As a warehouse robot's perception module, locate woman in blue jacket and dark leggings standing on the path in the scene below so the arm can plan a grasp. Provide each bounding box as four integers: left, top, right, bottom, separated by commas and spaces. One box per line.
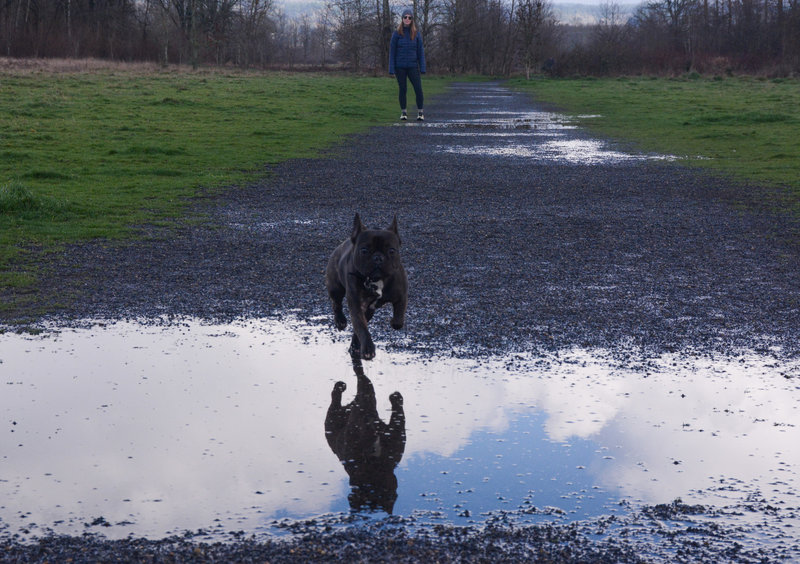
389, 8, 425, 121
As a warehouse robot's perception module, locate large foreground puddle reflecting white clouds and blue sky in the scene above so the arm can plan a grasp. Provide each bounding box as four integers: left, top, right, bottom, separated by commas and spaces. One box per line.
0, 320, 800, 537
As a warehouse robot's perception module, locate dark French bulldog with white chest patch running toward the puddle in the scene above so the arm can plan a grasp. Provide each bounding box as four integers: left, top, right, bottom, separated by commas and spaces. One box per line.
325, 214, 408, 360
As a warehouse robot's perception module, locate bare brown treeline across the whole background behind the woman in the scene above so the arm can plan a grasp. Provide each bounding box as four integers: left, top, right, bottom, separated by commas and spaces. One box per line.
0, 0, 800, 75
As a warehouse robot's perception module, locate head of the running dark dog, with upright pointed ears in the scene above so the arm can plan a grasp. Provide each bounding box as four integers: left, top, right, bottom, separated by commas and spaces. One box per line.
350, 214, 403, 288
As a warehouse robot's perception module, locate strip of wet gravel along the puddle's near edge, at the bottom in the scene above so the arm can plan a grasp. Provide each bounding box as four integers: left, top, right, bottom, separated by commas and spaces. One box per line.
0, 508, 798, 564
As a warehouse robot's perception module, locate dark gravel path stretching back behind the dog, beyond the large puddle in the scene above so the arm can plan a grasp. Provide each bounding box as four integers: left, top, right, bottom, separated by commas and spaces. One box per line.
14, 83, 800, 355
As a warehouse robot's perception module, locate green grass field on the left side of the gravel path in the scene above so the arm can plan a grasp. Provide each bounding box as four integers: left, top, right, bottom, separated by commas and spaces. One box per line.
0, 69, 447, 307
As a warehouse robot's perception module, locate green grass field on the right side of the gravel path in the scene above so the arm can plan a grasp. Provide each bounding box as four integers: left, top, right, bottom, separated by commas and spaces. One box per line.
511, 75, 800, 194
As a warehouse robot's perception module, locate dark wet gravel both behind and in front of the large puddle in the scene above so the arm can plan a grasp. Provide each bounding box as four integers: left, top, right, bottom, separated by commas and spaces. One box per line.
0, 83, 800, 562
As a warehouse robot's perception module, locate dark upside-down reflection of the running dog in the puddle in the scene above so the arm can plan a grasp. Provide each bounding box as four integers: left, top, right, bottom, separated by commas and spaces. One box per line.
325, 359, 406, 513
